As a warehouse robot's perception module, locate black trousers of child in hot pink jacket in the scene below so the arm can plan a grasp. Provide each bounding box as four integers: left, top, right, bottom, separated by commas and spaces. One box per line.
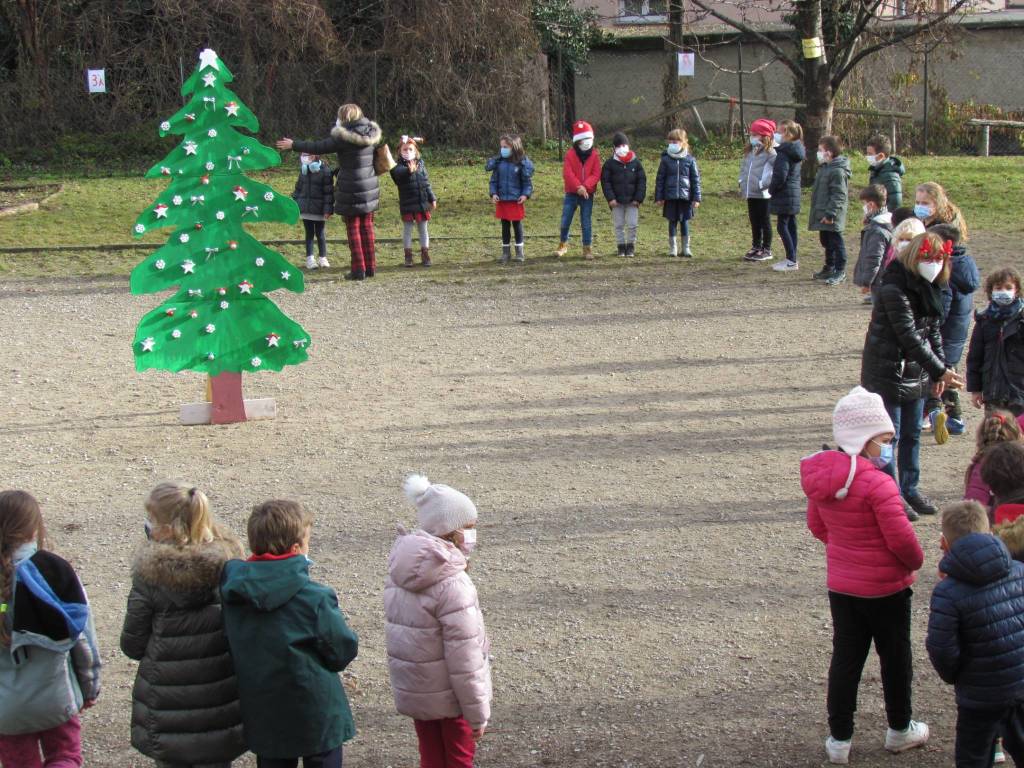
828, 588, 913, 741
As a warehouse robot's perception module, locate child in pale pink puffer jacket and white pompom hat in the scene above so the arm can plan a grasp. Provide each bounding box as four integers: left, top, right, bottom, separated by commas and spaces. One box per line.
384, 475, 490, 768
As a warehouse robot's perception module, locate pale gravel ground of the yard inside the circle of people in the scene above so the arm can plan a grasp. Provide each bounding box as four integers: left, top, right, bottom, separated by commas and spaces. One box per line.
0, 254, 991, 768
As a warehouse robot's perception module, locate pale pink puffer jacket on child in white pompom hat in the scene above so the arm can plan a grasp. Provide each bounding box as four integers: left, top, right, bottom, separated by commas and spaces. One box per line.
384, 530, 490, 728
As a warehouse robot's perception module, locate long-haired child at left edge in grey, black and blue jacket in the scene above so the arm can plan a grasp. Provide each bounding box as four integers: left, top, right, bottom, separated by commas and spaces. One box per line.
0, 490, 101, 768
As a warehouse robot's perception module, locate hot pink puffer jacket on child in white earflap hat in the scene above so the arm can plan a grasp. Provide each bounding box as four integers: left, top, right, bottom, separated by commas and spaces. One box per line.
800, 451, 925, 597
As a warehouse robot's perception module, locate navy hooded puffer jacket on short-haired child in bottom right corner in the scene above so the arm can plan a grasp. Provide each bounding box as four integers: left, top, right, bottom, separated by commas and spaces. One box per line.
926, 534, 1024, 710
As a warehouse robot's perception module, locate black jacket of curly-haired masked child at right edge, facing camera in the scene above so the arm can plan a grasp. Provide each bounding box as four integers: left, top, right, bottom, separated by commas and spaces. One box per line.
967, 301, 1024, 409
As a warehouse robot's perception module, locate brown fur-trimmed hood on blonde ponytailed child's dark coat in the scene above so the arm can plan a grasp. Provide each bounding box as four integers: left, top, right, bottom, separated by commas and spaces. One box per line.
131, 542, 238, 593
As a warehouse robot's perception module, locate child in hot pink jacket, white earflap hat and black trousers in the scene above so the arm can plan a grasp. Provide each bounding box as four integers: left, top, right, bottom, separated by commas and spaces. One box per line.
800, 387, 928, 763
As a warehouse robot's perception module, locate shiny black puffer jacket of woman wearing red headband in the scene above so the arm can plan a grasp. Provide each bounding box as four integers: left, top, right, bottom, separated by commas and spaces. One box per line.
860, 261, 946, 403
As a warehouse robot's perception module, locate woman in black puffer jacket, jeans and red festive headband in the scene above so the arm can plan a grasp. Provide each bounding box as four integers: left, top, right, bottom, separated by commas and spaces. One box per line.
860, 233, 964, 520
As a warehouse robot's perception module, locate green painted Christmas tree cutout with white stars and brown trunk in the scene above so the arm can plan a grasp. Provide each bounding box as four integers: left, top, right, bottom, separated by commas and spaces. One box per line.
131, 48, 309, 424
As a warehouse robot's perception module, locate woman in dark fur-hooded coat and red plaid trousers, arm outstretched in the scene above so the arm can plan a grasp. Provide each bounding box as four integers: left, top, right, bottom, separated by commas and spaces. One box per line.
276, 104, 381, 280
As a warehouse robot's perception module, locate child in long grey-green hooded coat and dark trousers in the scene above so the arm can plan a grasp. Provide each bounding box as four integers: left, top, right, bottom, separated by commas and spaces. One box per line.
808, 136, 850, 286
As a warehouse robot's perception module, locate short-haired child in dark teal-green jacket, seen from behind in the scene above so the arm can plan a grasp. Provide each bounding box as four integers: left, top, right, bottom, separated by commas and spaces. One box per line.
220, 501, 358, 768
